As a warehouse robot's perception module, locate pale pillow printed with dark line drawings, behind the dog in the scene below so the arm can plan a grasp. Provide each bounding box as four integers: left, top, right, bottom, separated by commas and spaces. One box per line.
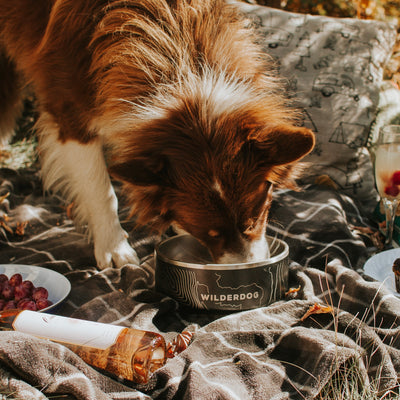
237, 3, 396, 213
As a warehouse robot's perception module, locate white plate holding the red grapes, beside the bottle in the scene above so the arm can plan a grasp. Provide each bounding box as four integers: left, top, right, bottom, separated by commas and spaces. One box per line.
0, 264, 71, 311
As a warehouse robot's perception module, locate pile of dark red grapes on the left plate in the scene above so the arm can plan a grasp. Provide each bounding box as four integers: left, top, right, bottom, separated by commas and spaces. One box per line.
0, 274, 53, 311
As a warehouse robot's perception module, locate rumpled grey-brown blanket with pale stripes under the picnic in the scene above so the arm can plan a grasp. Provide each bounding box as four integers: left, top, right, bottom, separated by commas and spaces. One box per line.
0, 169, 400, 400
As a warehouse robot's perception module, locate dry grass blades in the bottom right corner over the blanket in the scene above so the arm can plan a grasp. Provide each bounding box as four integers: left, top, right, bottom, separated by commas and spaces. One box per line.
287, 273, 400, 400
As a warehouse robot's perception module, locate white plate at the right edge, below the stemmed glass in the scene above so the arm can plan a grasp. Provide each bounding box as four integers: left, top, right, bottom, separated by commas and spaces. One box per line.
364, 248, 400, 297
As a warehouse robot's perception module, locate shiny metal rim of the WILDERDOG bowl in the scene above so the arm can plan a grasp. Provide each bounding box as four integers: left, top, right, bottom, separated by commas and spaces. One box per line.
155, 234, 289, 271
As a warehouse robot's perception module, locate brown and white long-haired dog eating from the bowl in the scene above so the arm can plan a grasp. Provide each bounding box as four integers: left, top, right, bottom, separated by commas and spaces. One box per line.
0, 0, 314, 268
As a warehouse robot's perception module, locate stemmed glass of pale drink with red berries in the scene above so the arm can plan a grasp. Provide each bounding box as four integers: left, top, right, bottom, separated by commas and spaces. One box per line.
375, 125, 400, 248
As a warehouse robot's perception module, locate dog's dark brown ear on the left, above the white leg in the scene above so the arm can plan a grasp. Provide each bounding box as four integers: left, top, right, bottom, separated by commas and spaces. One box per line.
109, 157, 168, 186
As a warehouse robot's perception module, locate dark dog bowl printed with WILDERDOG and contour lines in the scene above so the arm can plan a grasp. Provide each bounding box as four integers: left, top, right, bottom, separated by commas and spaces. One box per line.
155, 235, 289, 311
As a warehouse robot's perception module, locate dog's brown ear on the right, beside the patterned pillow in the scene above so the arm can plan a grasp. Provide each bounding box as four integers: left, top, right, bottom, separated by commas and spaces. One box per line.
249, 125, 315, 165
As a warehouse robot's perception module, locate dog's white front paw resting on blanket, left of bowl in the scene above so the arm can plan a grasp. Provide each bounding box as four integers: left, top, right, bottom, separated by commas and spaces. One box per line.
94, 234, 140, 269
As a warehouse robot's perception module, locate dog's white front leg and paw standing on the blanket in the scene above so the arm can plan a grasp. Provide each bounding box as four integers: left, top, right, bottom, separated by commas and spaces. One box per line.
37, 114, 139, 269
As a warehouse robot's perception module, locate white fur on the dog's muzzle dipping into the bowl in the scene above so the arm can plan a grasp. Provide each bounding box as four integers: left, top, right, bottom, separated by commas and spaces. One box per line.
217, 235, 270, 264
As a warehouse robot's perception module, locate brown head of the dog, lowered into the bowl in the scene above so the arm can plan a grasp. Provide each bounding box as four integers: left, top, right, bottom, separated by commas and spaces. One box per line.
111, 99, 314, 263
